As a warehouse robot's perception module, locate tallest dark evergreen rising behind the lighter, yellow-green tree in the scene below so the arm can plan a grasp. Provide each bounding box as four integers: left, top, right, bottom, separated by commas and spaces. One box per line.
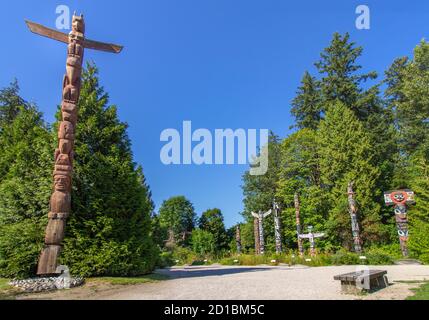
315, 33, 398, 228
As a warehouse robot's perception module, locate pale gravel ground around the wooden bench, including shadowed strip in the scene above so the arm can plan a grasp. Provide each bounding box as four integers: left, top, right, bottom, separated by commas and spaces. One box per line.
18, 265, 429, 300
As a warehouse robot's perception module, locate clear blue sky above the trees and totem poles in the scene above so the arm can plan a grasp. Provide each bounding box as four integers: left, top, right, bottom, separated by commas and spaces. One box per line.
0, 0, 429, 226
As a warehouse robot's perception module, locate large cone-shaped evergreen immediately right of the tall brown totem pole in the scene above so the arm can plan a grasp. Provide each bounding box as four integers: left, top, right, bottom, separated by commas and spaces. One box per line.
62, 64, 157, 276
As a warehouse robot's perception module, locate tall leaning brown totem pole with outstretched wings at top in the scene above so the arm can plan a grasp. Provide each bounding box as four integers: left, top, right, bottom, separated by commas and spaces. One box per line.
26, 15, 122, 276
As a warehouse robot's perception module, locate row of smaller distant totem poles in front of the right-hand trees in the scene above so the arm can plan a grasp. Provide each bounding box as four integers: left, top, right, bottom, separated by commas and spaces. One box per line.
236, 182, 415, 257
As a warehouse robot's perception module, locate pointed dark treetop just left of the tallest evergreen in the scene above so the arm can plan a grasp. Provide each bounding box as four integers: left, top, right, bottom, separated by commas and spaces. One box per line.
291, 71, 322, 129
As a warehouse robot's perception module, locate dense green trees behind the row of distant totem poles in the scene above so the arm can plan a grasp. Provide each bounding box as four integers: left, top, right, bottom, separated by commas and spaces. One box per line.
242, 33, 429, 262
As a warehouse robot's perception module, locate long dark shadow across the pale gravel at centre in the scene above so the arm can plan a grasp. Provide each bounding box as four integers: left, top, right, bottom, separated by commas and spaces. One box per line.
156, 267, 272, 279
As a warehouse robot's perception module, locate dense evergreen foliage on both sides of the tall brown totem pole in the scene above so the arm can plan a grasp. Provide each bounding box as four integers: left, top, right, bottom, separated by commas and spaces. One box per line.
0, 65, 158, 277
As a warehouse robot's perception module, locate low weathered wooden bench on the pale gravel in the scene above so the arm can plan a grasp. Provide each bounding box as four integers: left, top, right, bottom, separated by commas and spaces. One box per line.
334, 270, 389, 293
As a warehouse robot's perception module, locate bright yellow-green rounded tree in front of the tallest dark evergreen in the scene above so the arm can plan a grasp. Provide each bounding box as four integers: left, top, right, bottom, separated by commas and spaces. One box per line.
318, 102, 385, 248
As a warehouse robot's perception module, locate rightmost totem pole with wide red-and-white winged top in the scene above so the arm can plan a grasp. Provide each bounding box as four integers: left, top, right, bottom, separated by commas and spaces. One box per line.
384, 189, 416, 257
